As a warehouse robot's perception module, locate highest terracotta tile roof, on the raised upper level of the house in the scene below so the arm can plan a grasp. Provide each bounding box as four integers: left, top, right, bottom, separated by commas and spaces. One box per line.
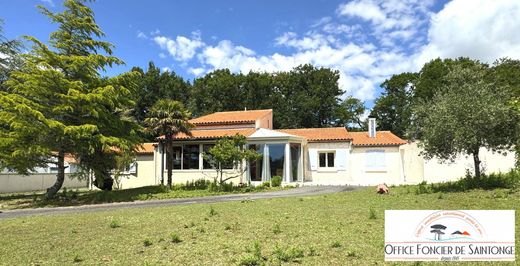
190, 109, 273, 125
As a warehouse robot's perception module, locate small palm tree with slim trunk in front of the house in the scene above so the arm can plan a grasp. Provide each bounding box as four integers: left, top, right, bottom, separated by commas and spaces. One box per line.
144, 99, 194, 188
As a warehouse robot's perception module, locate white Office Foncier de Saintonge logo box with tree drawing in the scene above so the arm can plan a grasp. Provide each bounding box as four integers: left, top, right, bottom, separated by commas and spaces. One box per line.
384, 210, 515, 261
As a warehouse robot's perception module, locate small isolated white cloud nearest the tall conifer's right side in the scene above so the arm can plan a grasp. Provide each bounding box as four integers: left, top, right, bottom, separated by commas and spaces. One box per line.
153, 36, 204, 61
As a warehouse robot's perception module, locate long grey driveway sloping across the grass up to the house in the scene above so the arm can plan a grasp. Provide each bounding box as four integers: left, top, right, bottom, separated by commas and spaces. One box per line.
0, 186, 358, 219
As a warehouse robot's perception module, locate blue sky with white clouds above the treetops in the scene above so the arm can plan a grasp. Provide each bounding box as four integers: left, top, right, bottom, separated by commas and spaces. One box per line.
0, 0, 520, 106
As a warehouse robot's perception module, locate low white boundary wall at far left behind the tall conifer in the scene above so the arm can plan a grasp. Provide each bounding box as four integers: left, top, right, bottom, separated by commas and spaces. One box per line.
0, 174, 87, 193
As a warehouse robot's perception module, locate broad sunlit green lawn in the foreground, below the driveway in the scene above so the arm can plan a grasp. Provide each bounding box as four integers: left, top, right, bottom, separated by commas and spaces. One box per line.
0, 186, 520, 265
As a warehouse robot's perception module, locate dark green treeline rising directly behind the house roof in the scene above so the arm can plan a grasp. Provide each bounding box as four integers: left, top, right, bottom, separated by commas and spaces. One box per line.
131, 62, 365, 140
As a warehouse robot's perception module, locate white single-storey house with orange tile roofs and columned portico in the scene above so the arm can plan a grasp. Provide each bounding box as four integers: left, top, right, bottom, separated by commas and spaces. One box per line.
122, 109, 414, 188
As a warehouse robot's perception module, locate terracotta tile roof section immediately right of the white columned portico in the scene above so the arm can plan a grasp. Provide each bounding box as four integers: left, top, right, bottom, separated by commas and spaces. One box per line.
276, 127, 351, 142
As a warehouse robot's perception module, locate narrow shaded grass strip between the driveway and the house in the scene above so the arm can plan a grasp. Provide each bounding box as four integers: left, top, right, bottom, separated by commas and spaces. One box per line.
0, 185, 285, 210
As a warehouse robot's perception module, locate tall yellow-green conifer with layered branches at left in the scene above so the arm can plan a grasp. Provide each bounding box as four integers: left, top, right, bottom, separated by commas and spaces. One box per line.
0, 0, 139, 198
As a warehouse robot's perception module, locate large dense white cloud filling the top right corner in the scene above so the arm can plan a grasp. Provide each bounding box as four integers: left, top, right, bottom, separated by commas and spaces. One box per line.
418, 0, 520, 62
